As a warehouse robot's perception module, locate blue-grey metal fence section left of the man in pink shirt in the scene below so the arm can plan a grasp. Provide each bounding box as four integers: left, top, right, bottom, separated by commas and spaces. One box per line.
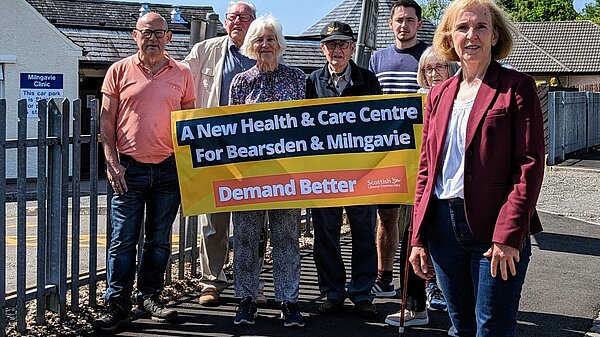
0, 99, 99, 335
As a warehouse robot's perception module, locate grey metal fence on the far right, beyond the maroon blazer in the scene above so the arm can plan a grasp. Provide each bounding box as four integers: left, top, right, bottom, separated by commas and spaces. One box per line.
547, 91, 600, 165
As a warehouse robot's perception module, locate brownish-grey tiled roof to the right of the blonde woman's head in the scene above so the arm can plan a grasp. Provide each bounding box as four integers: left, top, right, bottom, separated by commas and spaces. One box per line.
506, 21, 600, 73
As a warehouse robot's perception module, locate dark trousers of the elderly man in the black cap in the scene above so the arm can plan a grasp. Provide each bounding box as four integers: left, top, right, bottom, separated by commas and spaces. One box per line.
312, 206, 377, 303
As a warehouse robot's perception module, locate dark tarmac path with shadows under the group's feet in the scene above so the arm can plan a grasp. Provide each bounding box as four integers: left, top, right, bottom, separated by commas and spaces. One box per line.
97, 209, 600, 337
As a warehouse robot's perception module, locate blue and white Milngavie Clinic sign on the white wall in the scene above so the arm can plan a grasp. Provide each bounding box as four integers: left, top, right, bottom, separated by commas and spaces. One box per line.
20, 73, 64, 117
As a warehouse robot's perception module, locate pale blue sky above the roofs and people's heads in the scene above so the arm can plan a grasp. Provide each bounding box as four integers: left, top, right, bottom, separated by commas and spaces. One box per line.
112, 0, 593, 36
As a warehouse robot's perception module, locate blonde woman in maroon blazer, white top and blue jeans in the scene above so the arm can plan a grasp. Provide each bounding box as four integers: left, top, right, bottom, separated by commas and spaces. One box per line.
410, 0, 544, 337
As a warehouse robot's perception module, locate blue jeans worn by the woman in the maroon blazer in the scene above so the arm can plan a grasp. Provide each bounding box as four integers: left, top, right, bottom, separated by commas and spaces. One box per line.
426, 200, 531, 337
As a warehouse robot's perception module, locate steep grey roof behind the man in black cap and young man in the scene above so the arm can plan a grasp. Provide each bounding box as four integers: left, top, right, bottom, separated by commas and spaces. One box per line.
301, 0, 435, 49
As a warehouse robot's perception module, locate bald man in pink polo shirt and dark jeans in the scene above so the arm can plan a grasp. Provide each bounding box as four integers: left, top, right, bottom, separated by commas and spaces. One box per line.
92, 12, 196, 332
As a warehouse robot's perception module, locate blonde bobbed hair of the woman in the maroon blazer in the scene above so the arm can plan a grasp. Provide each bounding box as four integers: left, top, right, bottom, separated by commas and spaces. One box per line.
433, 0, 517, 61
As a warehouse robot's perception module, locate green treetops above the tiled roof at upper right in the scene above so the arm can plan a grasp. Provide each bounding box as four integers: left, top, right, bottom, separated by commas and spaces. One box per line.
505, 0, 580, 22
